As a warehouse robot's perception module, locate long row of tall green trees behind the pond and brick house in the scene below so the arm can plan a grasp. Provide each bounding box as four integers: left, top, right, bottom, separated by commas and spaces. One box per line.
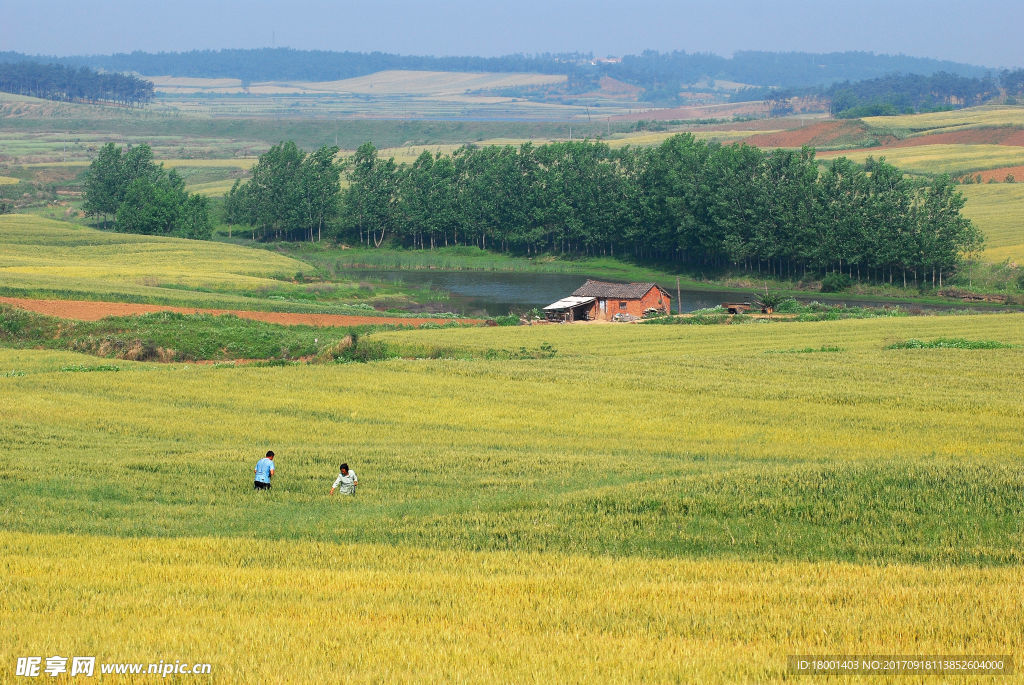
225, 134, 982, 283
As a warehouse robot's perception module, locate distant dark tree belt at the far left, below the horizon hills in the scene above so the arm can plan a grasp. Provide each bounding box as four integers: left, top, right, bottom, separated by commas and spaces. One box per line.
0, 61, 153, 106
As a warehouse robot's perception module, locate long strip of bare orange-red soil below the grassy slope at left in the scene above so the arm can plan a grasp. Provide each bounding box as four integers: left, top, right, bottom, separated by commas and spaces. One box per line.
0, 297, 483, 328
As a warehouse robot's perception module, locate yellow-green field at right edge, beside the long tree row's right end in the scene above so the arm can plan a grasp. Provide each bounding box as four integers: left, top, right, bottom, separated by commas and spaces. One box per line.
959, 183, 1024, 263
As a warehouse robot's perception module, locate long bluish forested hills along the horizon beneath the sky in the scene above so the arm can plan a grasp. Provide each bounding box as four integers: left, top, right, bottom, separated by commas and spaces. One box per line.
0, 48, 989, 94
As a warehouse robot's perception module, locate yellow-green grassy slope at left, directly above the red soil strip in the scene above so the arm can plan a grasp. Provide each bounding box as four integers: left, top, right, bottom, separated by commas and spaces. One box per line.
0, 214, 432, 313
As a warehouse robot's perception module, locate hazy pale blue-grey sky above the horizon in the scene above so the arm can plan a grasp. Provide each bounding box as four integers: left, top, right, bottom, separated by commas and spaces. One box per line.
8, 0, 1024, 67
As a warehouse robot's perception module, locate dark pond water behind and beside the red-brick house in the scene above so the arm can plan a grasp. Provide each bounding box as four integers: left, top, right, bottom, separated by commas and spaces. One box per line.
352, 269, 911, 316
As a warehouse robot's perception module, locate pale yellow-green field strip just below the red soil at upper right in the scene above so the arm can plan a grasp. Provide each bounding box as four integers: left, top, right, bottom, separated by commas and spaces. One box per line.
818, 144, 1024, 176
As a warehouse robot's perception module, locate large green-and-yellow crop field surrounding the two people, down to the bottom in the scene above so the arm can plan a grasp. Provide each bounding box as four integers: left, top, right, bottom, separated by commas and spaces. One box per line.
0, 314, 1024, 682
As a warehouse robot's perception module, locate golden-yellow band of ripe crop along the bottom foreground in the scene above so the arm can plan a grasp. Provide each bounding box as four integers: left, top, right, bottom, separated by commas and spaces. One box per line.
0, 528, 1024, 683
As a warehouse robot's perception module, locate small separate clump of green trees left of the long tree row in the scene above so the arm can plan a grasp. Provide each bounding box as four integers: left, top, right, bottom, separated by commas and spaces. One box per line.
83, 142, 213, 240
